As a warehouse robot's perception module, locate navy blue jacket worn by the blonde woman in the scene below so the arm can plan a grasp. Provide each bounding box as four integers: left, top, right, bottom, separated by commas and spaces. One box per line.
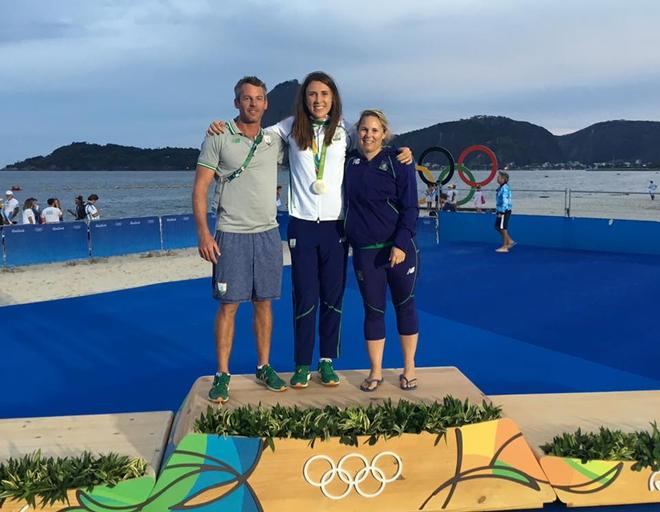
344, 147, 419, 251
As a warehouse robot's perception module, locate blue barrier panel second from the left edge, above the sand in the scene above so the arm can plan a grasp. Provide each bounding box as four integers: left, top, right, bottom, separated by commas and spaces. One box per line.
89, 217, 161, 257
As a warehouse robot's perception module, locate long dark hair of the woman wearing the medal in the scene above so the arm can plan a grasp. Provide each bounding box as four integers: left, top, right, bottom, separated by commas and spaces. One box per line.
291, 71, 341, 151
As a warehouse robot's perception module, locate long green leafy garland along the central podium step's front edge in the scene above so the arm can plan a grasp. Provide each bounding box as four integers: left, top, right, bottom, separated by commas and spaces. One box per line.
194, 396, 501, 449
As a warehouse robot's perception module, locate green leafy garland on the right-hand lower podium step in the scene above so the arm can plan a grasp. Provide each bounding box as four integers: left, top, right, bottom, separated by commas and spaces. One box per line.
541, 422, 660, 471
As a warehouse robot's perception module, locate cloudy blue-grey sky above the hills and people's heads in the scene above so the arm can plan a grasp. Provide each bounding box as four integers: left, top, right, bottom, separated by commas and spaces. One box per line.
0, 0, 660, 168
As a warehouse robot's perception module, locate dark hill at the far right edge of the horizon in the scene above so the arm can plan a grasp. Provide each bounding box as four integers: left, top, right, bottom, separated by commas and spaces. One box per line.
557, 121, 660, 162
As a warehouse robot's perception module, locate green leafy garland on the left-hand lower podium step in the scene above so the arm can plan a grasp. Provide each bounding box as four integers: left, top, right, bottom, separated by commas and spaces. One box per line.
0, 451, 147, 508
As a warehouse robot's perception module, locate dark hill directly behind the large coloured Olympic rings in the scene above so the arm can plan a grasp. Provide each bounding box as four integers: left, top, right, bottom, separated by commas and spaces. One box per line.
393, 116, 564, 165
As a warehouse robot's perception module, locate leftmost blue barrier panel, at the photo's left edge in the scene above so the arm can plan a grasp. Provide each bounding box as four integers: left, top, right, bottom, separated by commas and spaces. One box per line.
2, 222, 89, 266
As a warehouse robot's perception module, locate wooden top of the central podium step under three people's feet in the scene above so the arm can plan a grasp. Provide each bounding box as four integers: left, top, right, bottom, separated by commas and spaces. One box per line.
170, 367, 488, 443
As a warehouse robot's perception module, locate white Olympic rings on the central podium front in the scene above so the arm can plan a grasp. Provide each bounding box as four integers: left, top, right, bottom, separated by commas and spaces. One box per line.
303, 452, 403, 500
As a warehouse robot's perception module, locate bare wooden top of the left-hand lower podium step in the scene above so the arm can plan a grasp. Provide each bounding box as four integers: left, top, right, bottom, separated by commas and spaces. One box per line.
0, 411, 173, 471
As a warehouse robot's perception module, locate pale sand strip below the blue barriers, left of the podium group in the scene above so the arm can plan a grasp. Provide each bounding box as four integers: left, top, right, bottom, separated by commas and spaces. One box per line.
0, 244, 291, 306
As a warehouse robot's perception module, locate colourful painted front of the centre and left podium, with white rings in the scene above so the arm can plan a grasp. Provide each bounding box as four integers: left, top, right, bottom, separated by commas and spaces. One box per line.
0, 419, 556, 512
